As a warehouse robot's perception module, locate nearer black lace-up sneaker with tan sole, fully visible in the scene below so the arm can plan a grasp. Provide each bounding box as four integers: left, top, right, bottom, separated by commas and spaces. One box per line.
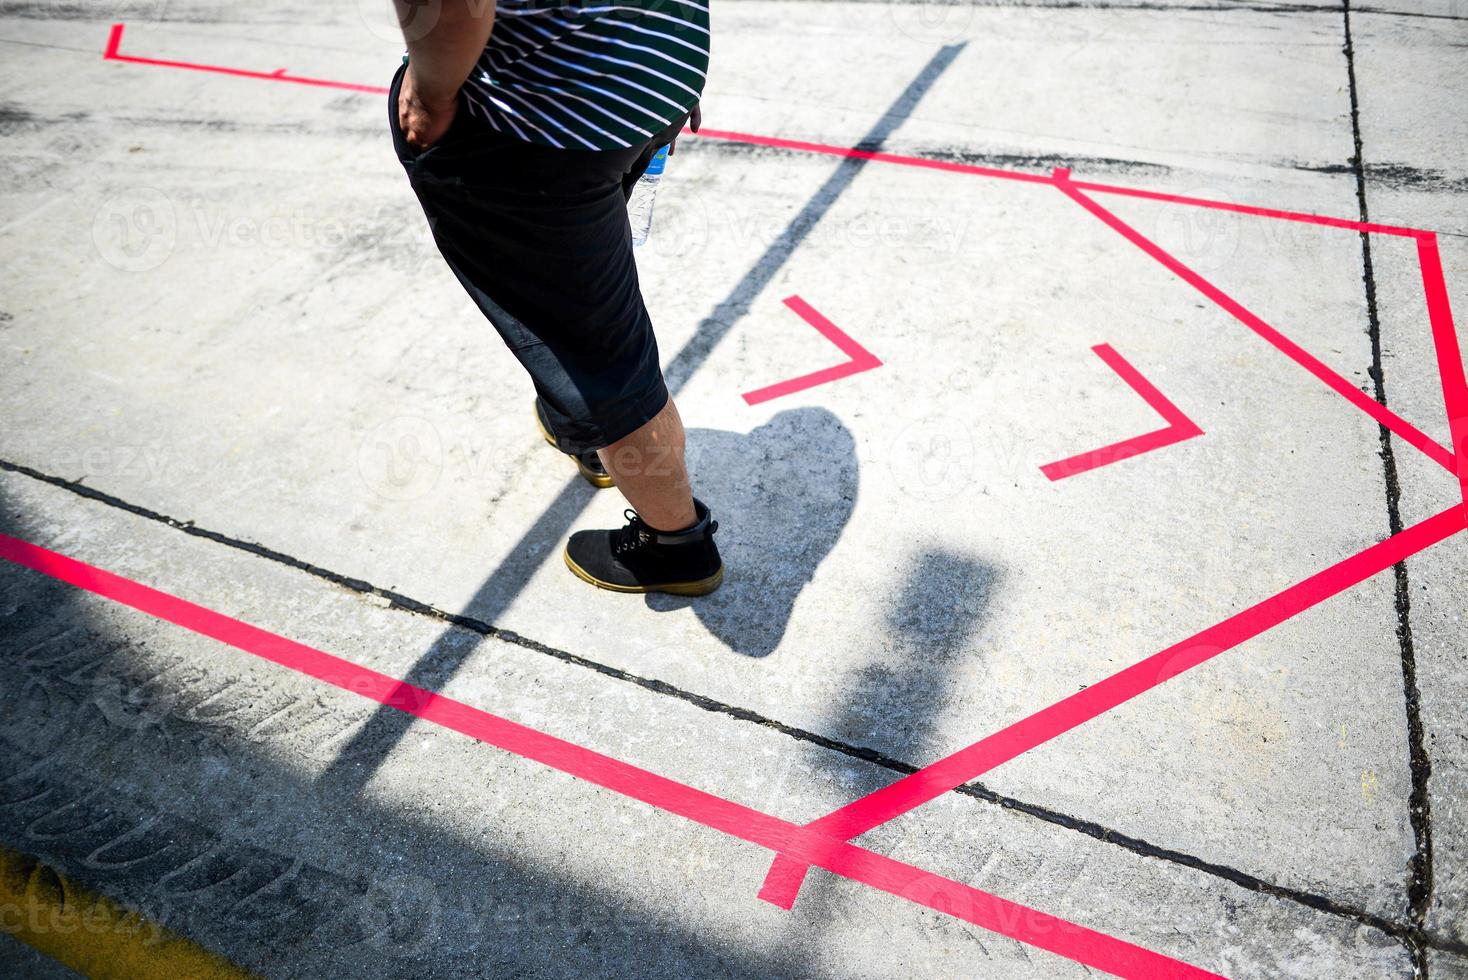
565, 500, 724, 596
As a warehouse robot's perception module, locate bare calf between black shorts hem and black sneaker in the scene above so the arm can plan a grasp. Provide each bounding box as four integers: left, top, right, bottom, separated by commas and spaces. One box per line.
597, 398, 697, 531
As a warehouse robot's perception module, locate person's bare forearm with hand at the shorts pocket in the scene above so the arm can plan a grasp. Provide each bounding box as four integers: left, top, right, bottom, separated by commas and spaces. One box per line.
393, 0, 495, 150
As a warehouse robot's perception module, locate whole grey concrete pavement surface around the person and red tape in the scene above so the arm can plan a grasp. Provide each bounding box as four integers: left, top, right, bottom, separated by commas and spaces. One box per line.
0, 0, 1468, 977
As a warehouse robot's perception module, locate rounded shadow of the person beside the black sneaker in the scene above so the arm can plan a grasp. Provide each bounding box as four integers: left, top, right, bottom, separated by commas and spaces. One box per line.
647, 408, 857, 657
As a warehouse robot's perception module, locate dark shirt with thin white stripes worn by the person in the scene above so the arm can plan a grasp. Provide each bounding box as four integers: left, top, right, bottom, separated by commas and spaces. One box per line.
464, 0, 709, 150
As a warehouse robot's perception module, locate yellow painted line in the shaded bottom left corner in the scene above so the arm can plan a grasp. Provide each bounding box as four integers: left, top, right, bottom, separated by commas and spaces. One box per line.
0, 846, 251, 980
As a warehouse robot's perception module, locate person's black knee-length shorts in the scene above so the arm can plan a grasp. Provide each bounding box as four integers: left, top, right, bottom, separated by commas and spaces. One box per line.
388, 66, 683, 453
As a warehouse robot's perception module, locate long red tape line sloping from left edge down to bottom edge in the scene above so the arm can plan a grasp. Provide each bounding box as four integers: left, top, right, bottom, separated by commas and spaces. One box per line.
0, 534, 1218, 980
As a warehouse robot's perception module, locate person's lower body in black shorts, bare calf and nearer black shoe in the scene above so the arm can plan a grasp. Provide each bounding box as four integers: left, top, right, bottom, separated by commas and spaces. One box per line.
389, 72, 724, 596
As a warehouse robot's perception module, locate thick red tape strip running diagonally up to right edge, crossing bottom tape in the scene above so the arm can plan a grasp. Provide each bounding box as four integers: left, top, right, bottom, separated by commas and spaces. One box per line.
759, 506, 1468, 908
